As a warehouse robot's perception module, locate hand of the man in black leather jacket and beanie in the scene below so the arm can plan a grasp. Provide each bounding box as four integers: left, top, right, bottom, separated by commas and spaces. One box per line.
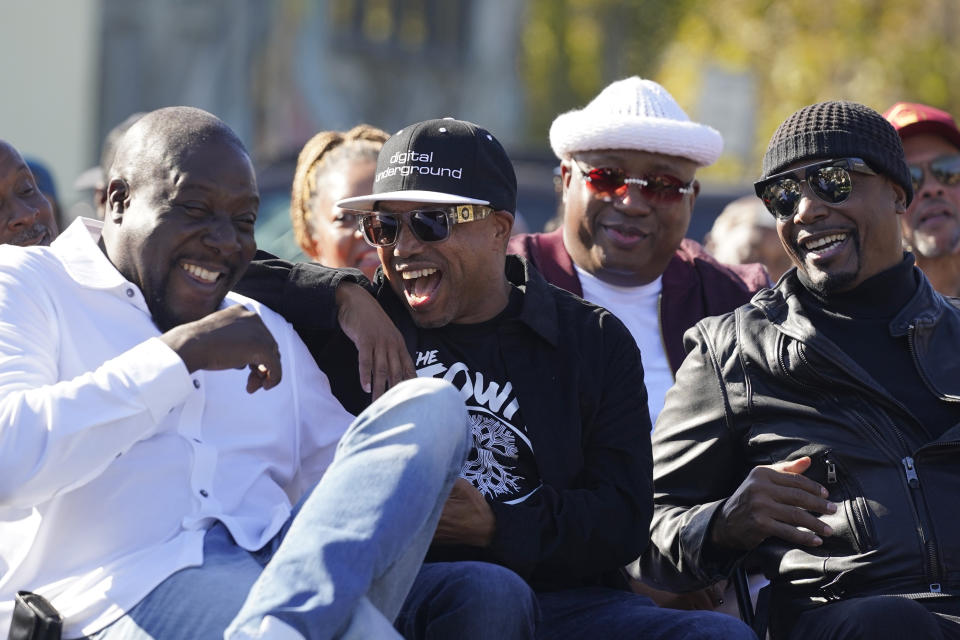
710, 456, 837, 550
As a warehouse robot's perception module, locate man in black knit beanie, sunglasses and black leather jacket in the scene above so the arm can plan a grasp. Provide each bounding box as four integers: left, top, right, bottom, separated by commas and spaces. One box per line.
643, 101, 960, 640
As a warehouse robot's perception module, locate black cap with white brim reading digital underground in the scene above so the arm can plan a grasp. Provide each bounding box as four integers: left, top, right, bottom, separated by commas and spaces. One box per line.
337, 118, 517, 213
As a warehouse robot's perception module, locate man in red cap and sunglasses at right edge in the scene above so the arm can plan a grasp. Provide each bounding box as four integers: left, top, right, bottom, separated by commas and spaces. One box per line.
883, 102, 960, 296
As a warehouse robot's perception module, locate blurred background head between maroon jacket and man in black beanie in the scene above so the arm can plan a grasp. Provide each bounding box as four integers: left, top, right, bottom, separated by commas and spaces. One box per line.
704, 195, 791, 282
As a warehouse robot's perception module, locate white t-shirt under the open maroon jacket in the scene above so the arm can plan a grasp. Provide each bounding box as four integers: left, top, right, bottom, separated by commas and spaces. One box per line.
574, 265, 673, 424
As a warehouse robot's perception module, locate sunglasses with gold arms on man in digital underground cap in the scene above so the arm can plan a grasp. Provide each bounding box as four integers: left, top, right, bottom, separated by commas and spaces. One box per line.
360, 204, 493, 247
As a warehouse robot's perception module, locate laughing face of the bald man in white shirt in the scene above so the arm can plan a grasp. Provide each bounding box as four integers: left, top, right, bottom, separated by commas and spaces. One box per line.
104, 127, 259, 331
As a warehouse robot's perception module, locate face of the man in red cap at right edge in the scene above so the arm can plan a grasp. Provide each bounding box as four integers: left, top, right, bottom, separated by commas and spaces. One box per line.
901, 134, 960, 259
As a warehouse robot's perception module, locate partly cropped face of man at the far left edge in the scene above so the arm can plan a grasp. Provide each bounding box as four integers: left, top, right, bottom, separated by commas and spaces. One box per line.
0, 140, 57, 247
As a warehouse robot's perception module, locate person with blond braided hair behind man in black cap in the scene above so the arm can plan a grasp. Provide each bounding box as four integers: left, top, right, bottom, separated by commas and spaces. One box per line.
290, 124, 389, 278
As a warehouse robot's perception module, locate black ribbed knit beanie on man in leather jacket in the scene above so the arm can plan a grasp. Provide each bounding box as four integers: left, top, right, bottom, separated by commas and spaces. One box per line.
761, 100, 913, 206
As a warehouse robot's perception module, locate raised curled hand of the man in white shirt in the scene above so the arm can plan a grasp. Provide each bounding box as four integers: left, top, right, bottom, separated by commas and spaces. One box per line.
160, 305, 282, 393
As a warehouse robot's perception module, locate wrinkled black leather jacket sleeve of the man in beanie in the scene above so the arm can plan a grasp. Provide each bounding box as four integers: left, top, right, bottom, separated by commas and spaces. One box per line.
642, 312, 745, 591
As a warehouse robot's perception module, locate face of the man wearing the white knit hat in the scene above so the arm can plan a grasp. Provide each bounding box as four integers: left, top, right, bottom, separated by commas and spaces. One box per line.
561, 150, 699, 286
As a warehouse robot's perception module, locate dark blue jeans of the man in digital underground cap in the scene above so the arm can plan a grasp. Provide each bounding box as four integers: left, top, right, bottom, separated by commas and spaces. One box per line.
396, 562, 756, 640
